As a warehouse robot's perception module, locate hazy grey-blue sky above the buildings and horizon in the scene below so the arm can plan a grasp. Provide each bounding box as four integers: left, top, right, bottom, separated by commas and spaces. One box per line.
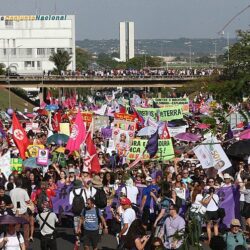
0, 0, 250, 40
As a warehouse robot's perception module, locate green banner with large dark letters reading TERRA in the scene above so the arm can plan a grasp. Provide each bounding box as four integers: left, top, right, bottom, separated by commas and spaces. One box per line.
136, 106, 183, 122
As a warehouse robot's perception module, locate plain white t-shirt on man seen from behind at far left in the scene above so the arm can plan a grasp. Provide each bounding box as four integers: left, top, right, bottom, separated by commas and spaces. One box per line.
10, 187, 30, 214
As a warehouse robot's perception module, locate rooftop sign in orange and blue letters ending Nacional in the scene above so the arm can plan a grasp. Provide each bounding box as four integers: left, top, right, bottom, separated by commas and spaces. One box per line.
0, 15, 67, 21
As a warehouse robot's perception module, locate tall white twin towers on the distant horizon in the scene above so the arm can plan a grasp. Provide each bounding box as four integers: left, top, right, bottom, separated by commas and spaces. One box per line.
120, 22, 135, 62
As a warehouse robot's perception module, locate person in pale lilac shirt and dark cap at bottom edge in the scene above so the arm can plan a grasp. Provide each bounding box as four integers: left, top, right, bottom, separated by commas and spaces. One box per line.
163, 204, 186, 250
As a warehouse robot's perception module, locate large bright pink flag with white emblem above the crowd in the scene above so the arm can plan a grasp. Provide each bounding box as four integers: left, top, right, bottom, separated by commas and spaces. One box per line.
66, 111, 86, 152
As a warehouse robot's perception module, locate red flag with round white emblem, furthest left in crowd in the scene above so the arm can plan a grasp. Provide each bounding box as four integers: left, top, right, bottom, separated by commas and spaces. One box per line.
12, 113, 29, 159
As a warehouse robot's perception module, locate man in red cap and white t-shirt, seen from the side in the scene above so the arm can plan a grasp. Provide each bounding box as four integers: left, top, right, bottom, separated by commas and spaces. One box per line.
119, 197, 136, 242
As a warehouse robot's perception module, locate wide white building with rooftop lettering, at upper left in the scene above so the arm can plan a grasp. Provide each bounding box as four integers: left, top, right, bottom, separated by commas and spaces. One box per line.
0, 15, 75, 74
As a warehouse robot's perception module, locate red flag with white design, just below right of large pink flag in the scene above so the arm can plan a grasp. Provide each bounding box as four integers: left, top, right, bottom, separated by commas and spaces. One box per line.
84, 133, 101, 173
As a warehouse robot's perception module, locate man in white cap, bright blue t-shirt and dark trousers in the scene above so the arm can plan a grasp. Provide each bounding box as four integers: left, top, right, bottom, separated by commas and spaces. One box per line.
140, 176, 160, 229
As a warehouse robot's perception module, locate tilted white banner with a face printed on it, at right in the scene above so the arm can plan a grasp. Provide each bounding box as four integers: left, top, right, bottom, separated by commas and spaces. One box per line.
193, 137, 232, 173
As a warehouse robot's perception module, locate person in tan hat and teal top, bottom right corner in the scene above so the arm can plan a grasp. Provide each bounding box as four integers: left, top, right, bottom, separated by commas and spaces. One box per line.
223, 219, 247, 250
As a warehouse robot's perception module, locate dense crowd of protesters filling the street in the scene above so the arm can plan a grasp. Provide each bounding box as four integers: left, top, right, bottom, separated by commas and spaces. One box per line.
0, 90, 250, 250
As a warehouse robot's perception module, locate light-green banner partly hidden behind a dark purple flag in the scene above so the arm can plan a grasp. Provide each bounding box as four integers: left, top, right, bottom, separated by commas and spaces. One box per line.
127, 139, 174, 161
